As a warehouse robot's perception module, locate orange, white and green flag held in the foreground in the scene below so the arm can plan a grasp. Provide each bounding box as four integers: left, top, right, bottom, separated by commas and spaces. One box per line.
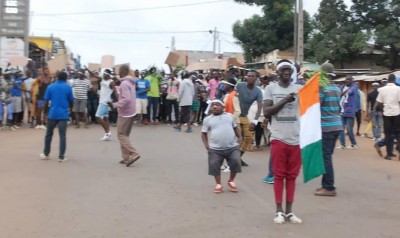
298, 73, 325, 183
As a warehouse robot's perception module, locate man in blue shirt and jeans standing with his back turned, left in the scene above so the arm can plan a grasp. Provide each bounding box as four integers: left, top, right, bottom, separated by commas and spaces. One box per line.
40, 72, 74, 162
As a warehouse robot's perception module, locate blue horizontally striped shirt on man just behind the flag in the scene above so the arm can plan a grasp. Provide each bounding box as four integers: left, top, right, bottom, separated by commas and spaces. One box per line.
319, 85, 343, 132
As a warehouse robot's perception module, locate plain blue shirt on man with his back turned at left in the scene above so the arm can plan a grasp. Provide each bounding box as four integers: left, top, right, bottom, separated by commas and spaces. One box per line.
44, 81, 74, 120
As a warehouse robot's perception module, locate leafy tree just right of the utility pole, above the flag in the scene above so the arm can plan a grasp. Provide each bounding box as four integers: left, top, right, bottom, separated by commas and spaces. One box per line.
306, 0, 367, 68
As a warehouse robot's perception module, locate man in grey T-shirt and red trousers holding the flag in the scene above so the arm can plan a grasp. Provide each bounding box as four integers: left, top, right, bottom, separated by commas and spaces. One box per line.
264, 60, 302, 224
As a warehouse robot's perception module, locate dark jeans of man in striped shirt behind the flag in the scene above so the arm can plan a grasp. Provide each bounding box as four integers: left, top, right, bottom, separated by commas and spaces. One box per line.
322, 131, 342, 191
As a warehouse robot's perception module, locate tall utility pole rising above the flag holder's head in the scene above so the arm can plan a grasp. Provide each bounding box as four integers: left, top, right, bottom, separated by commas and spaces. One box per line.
294, 0, 304, 66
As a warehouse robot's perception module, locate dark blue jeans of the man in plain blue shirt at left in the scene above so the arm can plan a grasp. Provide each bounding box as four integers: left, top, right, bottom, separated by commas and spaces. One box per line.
43, 119, 68, 159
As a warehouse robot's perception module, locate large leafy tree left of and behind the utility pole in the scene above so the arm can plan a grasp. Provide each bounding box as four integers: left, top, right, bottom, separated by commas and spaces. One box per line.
233, 0, 311, 61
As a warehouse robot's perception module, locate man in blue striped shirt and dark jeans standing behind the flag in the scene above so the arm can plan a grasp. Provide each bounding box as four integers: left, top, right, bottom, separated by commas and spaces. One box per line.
314, 63, 343, 196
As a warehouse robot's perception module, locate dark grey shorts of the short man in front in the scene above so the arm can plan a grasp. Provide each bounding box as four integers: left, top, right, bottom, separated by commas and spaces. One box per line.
208, 146, 242, 176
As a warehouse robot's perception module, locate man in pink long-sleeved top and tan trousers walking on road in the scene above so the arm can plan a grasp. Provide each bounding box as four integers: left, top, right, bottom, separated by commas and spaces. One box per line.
108, 65, 140, 167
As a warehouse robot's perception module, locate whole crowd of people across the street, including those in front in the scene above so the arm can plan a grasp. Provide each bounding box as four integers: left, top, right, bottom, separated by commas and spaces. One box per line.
0, 60, 400, 224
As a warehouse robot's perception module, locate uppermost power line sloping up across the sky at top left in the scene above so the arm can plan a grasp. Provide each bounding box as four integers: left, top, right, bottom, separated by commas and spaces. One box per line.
34, 0, 227, 16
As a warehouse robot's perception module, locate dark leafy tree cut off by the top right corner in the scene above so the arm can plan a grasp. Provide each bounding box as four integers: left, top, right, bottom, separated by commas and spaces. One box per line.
351, 0, 400, 69
